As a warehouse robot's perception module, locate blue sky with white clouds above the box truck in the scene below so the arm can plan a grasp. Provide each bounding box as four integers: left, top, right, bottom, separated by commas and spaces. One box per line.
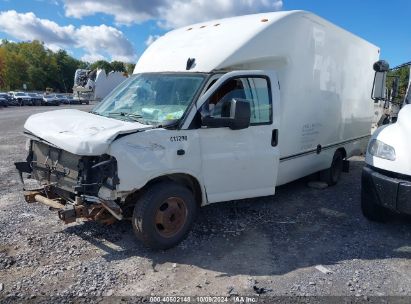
0, 0, 411, 66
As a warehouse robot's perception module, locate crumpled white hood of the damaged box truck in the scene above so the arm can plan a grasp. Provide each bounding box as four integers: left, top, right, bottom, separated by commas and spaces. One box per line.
24, 109, 152, 156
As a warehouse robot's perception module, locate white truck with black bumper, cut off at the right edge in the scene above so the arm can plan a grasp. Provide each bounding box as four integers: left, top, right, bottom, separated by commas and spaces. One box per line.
361, 61, 411, 222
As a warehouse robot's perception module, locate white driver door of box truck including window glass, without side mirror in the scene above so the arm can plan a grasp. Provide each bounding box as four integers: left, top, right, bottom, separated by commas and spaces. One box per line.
193, 71, 279, 203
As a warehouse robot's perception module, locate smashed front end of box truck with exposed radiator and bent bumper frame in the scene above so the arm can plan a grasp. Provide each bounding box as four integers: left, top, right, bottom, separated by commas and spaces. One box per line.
15, 140, 123, 224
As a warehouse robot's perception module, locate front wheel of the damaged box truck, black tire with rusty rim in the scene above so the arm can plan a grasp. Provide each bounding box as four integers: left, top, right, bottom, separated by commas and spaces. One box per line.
132, 182, 197, 250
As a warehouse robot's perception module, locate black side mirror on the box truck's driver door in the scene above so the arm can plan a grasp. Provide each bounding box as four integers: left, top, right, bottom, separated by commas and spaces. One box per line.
202, 99, 251, 130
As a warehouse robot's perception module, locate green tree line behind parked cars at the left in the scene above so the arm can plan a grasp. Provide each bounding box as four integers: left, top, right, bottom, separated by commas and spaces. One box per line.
0, 40, 135, 93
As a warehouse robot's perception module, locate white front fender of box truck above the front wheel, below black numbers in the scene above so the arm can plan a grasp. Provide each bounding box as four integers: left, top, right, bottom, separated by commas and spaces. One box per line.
108, 128, 203, 196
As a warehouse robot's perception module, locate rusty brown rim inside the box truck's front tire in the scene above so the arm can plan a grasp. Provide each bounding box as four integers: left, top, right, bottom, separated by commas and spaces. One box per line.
154, 197, 187, 238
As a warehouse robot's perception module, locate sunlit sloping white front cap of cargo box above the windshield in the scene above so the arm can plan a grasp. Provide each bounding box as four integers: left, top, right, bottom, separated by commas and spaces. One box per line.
134, 12, 296, 73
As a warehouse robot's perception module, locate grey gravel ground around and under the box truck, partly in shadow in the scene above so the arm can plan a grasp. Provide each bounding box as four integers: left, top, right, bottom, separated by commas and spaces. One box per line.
0, 106, 411, 302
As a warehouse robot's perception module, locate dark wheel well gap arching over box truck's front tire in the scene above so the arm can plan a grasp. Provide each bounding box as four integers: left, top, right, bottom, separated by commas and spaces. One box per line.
126, 173, 203, 207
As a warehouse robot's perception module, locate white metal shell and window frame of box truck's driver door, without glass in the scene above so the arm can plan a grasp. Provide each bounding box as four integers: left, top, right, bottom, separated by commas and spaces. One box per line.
198, 71, 280, 203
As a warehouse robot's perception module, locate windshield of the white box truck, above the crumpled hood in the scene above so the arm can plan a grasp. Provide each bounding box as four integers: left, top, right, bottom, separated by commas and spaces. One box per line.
92, 73, 206, 125
